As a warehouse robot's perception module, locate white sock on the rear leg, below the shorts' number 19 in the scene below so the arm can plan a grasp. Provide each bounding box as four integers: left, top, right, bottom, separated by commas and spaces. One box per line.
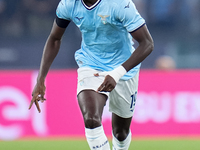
112, 132, 131, 150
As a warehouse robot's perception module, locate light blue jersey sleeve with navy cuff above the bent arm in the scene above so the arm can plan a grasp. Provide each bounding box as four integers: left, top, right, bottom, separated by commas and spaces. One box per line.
117, 0, 145, 32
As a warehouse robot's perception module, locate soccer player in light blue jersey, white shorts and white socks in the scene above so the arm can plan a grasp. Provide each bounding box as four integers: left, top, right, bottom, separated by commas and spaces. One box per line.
29, 0, 154, 150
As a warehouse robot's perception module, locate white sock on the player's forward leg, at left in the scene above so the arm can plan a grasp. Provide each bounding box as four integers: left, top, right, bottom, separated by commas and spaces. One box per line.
85, 126, 110, 150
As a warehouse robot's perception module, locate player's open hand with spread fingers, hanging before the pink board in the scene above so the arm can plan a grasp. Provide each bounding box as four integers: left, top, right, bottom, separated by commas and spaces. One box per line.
29, 83, 46, 113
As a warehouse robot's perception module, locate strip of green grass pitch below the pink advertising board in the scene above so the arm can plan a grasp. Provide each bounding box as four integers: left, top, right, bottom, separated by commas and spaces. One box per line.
0, 138, 200, 150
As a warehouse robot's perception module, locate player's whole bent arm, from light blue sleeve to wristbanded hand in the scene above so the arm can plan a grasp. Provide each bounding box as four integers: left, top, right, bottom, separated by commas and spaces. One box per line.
96, 0, 154, 92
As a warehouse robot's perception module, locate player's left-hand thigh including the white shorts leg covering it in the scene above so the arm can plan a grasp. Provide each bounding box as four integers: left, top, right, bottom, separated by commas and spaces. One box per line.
77, 67, 109, 116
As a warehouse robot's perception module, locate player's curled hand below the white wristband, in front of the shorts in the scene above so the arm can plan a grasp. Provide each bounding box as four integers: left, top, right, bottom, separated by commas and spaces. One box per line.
94, 72, 117, 92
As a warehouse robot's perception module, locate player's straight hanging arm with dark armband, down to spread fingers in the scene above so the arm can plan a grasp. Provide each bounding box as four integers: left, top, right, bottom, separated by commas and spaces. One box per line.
29, 17, 70, 112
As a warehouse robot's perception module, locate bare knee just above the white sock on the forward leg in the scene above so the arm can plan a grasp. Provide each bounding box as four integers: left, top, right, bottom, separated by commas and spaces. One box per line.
84, 116, 101, 129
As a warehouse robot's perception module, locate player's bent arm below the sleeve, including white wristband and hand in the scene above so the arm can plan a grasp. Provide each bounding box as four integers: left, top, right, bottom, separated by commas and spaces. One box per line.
95, 24, 154, 92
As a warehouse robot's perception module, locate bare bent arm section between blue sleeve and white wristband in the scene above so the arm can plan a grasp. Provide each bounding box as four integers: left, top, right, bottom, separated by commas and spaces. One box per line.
122, 24, 154, 72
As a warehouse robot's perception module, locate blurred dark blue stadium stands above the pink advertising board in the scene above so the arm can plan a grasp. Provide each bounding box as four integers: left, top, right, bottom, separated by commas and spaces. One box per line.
0, 0, 200, 69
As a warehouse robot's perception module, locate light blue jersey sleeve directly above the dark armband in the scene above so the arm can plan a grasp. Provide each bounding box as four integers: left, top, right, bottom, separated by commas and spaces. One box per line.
56, 0, 71, 20
